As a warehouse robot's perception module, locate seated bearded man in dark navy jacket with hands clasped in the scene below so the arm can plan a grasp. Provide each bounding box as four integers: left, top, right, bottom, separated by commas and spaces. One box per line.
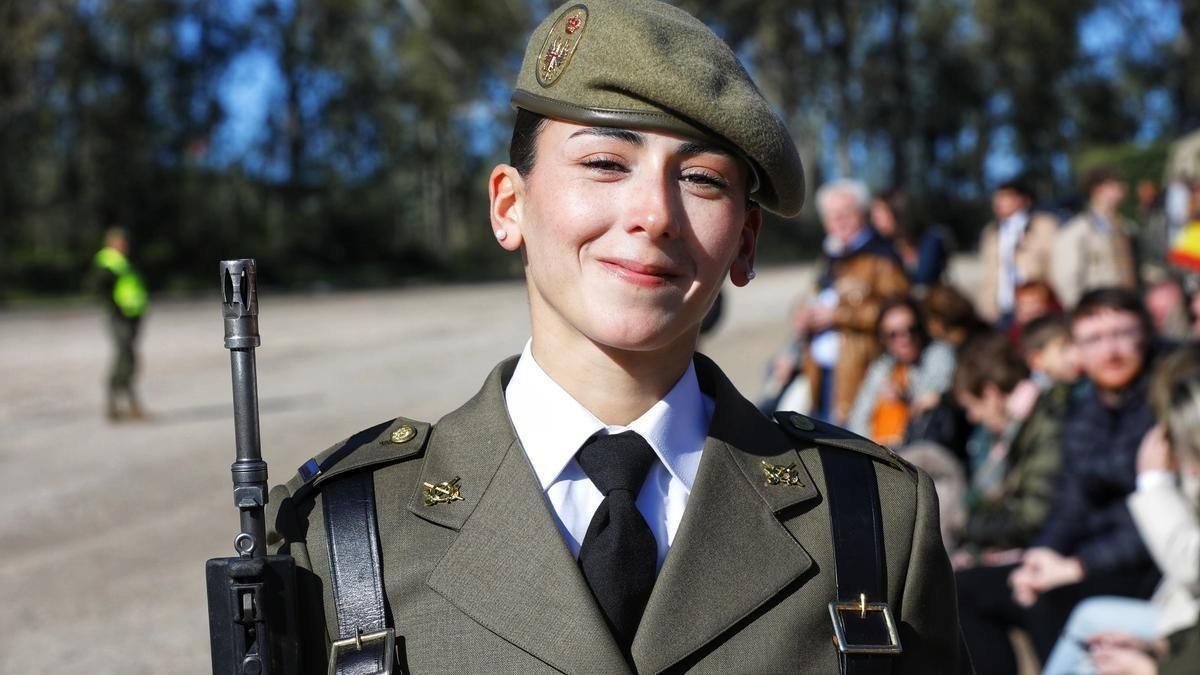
956, 288, 1158, 675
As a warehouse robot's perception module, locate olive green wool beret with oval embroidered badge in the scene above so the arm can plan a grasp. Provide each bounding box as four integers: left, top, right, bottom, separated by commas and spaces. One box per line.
512, 0, 804, 216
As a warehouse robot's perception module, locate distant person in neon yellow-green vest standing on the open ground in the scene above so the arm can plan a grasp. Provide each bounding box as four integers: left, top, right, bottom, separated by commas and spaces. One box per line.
94, 227, 148, 422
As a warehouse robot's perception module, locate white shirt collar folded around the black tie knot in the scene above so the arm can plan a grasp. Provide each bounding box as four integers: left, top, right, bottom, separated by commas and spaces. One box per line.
504, 342, 714, 492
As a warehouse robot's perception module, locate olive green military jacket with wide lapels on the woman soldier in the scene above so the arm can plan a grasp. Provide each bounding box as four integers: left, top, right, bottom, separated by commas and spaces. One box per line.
268, 356, 971, 675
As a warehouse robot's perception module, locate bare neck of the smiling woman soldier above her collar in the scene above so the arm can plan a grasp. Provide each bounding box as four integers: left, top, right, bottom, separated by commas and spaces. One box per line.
530, 322, 696, 426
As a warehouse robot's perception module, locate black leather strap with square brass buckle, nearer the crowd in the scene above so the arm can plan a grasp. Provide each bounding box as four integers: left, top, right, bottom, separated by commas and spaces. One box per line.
821, 446, 898, 675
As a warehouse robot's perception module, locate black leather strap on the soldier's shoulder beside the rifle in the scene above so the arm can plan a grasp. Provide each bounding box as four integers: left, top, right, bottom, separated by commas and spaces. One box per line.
322, 471, 395, 675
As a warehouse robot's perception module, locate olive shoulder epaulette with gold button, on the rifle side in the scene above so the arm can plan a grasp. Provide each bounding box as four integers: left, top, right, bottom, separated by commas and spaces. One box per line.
288, 417, 430, 497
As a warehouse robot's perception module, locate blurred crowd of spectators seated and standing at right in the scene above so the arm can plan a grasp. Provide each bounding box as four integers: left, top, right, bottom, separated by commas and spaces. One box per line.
761, 168, 1200, 674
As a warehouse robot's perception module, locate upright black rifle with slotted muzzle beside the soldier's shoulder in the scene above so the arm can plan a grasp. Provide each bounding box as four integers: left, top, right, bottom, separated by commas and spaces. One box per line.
205, 258, 300, 675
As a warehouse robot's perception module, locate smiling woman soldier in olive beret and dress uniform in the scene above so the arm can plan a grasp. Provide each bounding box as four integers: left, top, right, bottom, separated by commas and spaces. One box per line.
270, 0, 970, 674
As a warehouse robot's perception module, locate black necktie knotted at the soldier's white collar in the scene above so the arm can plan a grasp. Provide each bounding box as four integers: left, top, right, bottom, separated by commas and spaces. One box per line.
576, 431, 658, 655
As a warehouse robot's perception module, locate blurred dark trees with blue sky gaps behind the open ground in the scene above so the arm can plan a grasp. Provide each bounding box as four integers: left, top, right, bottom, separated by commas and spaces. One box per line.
0, 0, 1200, 300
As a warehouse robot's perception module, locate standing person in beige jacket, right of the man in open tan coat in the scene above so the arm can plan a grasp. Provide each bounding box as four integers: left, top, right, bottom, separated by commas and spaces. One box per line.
1050, 167, 1138, 307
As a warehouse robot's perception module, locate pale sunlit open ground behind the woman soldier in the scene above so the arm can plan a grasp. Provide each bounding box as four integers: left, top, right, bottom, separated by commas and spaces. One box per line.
0, 255, 974, 675
